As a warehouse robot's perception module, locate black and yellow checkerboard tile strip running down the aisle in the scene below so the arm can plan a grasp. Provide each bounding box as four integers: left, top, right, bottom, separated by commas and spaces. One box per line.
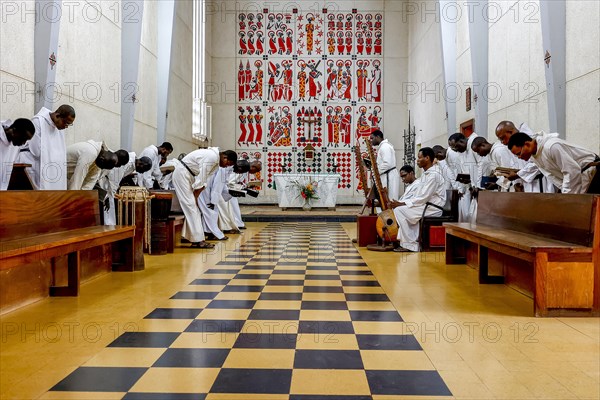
46, 223, 452, 400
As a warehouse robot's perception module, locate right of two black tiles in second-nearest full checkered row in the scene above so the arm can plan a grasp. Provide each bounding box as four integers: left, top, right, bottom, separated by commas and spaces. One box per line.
294, 350, 363, 369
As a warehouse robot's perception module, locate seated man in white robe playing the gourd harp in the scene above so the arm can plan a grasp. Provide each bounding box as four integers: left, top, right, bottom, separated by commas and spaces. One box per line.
390, 147, 446, 252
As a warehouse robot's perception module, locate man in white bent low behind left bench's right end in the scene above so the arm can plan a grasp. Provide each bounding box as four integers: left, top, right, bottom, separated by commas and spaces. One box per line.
67, 140, 119, 190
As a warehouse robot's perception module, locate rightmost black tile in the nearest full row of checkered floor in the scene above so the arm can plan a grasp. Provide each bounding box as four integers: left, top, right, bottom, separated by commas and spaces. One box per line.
367, 371, 452, 396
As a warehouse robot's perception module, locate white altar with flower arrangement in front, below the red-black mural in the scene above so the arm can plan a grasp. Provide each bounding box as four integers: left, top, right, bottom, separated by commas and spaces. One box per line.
273, 174, 342, 209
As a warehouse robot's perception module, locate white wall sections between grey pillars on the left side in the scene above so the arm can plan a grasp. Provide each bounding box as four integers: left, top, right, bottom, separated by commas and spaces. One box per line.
0, 0, 195, 152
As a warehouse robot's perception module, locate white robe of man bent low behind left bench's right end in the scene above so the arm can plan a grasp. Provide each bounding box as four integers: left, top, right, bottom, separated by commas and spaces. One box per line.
67, 140, 106, 190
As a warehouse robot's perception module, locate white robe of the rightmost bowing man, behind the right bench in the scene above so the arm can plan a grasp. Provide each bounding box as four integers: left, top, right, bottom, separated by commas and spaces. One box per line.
530, 132, 596, 194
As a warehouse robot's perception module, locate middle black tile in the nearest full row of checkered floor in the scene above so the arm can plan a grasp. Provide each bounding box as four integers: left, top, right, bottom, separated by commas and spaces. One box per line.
210, 368, 292, 394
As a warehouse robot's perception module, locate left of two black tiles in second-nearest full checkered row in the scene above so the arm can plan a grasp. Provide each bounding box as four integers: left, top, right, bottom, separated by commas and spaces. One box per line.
152, 348, 229, 368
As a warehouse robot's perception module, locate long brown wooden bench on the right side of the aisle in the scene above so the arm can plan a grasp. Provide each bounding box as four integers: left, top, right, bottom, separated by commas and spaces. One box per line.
444, 192, 600, 316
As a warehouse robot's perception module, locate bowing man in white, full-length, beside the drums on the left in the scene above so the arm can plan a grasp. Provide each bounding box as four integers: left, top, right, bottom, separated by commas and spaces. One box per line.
172, 147, 237, 249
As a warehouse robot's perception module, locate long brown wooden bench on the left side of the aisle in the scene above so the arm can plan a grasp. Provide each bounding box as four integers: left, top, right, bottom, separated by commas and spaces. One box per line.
0, 191, 134, 309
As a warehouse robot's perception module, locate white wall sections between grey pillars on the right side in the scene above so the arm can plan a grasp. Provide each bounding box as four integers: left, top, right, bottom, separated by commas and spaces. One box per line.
408, 0, 600, 152
